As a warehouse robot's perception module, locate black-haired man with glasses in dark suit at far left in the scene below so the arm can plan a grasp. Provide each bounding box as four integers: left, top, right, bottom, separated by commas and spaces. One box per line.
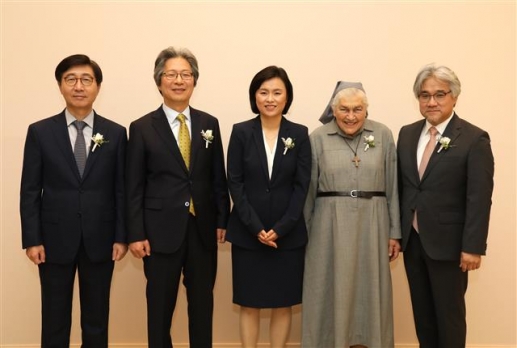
20, 54, 127, 348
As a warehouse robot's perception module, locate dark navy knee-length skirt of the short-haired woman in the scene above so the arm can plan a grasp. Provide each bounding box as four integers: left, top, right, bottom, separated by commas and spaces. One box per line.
232, 244, 305, 308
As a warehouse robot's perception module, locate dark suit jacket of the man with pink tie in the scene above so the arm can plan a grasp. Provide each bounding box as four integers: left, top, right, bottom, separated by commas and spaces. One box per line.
397, 114, 494, 261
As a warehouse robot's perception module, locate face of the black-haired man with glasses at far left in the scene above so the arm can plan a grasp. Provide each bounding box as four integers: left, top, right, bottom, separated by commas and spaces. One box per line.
59, 65, 100, 116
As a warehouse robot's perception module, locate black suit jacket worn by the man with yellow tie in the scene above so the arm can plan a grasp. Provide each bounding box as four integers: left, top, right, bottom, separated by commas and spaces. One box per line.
126, 106, 230, 253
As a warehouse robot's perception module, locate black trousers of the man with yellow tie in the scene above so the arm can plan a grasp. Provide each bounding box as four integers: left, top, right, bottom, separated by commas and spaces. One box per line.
144, 216, 217, 348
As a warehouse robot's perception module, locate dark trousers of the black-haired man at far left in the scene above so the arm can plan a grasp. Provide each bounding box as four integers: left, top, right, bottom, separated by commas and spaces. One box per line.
39, 247, 114, 348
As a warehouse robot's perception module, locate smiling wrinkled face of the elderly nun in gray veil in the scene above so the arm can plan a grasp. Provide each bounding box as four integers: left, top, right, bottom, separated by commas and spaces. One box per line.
333, 95, 367, 135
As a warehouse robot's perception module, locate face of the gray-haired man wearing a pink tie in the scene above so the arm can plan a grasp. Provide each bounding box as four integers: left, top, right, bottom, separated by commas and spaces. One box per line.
418, 77, 458, 126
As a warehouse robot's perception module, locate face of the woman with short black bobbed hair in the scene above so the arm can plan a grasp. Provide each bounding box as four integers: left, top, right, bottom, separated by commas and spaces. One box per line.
255, 77, 287, 117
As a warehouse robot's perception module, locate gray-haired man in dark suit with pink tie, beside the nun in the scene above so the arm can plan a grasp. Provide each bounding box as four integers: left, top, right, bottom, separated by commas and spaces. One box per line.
397, 65, 494, 348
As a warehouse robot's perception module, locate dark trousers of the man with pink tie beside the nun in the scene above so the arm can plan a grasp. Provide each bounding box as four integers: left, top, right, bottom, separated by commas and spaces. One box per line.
403, 229, 468, 348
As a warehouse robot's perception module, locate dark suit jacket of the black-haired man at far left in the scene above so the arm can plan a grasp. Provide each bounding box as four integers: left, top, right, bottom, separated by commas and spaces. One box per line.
20, 111, 127, 263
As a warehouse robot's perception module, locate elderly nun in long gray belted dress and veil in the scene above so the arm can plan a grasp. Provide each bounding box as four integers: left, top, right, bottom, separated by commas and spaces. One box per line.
302, 82, 401, 348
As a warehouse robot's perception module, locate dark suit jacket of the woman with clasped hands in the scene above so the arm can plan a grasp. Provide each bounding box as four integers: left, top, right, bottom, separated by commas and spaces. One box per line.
226, 116, 311, 249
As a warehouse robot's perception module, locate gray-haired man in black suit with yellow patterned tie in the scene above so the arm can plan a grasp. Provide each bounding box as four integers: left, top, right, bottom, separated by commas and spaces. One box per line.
126, 47, 230, 348
